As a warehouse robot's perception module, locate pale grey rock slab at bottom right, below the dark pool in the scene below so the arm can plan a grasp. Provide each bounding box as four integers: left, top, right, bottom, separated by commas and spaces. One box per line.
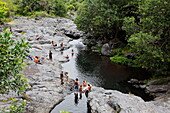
88, 87, 170, 113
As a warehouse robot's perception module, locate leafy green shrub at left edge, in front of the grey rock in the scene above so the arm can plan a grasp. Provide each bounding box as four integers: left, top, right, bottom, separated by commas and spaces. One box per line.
0, 30, 30, 94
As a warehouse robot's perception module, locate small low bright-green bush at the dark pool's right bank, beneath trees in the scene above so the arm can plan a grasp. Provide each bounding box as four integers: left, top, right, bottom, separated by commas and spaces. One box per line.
110, 55, 132, 65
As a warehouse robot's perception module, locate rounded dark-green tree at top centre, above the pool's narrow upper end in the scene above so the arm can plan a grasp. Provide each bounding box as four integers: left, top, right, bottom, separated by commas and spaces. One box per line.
75, 0, 131, 39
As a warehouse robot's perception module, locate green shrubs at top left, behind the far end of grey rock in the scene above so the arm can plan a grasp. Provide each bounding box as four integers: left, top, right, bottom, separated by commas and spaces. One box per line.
14, 0, 67, 16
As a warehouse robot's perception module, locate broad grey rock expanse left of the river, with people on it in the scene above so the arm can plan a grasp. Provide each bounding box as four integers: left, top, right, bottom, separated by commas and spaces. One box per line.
0, 17, 82, 113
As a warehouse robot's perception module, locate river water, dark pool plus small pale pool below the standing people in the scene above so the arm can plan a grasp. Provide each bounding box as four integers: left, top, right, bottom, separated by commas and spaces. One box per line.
51, 39, 152, 113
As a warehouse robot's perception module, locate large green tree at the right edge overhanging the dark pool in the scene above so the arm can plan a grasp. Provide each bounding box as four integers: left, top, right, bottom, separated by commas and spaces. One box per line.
123, 0, 170, 74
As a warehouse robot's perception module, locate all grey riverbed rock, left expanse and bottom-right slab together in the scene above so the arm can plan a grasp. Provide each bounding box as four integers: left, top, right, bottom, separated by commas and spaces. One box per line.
0, 17, 170, 113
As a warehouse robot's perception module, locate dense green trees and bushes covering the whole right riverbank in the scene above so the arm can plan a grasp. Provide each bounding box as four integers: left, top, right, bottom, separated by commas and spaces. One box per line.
75, 0, 170, 75
